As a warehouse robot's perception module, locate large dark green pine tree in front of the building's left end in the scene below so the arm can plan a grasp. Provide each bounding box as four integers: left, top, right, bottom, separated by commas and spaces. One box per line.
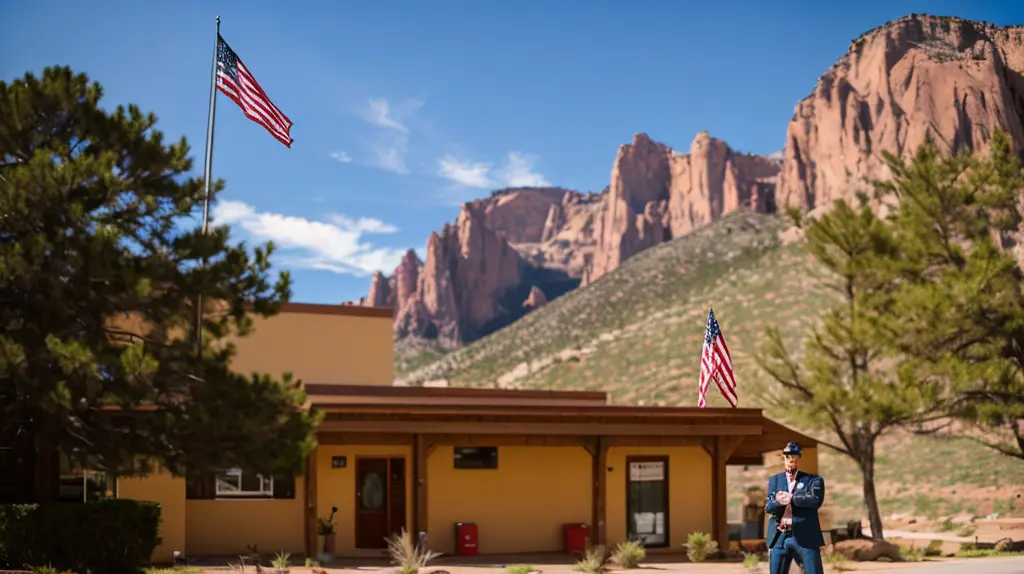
0, 68, 316, 500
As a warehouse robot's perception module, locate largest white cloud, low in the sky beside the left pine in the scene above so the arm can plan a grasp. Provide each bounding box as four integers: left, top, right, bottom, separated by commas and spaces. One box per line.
213, 201, 404, 276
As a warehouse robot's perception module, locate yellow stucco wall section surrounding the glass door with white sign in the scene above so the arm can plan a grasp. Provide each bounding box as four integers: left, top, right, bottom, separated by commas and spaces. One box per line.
605, 446, 712, 551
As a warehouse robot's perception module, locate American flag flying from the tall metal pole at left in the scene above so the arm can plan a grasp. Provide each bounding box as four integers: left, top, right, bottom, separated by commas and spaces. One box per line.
217, 34, 295, 147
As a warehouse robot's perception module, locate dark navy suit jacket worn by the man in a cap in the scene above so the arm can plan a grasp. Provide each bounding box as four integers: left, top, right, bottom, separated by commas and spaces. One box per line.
765, 471, 825, 548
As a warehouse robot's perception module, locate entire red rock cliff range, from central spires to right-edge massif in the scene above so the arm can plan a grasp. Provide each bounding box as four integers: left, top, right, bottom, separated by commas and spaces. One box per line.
361, 15, 1024, 343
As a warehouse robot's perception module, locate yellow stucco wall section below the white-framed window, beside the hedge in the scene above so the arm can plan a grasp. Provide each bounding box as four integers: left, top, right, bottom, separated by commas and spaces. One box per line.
184, 477, 305, 558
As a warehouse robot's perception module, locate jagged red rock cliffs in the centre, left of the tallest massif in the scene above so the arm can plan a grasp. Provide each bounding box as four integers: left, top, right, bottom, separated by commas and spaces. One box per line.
358, 132, 781, 344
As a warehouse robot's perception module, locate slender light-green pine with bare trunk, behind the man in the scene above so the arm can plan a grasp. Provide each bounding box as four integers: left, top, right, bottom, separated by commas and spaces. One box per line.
757, 196, 937, 539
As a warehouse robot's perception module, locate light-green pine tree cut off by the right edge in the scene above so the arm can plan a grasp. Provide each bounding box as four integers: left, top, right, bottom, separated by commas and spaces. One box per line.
878, 132, 1024, 459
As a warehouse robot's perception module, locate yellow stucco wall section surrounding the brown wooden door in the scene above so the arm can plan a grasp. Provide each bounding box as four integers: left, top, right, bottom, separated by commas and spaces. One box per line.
316, 445, 415, 556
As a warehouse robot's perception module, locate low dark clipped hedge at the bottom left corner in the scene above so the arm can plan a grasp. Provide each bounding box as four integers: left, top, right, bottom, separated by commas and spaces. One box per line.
0, 499, 160, 574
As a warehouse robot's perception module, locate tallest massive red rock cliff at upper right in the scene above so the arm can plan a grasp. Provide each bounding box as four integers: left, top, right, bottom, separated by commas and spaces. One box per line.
776, 15, 1024, 210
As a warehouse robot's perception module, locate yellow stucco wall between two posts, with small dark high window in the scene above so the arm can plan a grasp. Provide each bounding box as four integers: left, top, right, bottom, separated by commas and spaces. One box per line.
427, 446, 593, 554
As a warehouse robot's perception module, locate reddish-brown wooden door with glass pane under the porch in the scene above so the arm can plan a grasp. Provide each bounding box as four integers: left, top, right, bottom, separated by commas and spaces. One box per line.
355, 458, 390, 548
